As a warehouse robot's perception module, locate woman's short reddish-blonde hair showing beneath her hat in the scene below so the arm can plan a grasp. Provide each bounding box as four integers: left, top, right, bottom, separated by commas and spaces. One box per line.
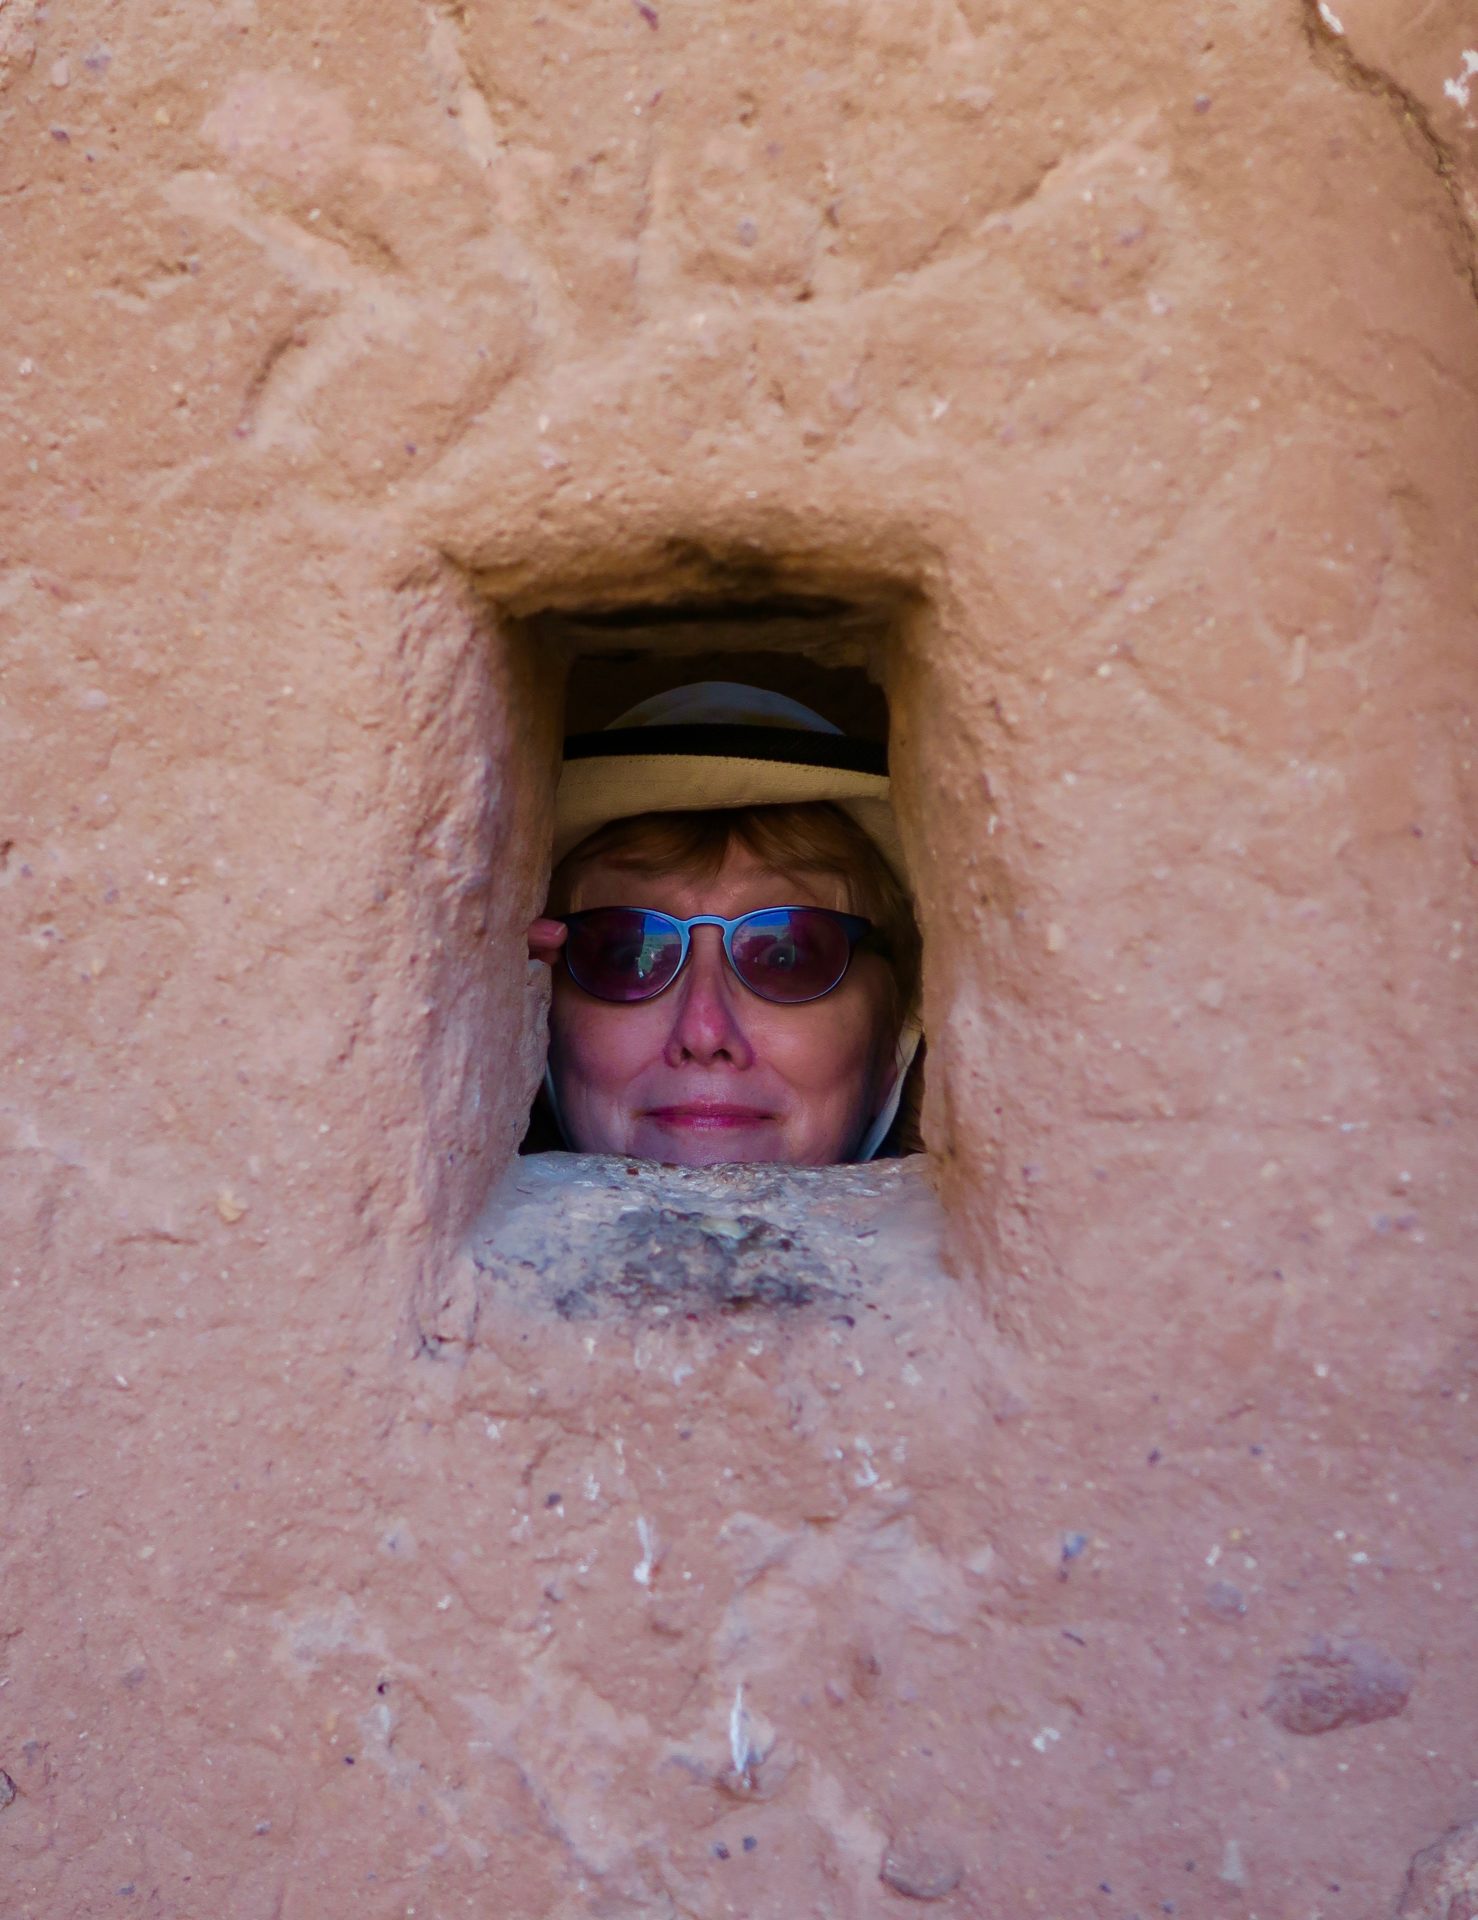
549, 801, 919, 1021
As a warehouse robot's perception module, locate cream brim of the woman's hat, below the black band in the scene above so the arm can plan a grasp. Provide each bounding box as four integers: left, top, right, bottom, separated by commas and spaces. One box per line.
555, 752, 912, 891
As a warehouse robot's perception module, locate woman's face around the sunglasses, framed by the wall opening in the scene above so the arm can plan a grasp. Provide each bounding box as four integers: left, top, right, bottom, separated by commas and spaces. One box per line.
549, 847, 894, 1167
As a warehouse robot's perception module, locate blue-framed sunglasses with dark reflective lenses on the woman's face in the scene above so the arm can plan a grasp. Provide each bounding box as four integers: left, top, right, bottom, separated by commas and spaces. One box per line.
562, 906, 873, 1006
